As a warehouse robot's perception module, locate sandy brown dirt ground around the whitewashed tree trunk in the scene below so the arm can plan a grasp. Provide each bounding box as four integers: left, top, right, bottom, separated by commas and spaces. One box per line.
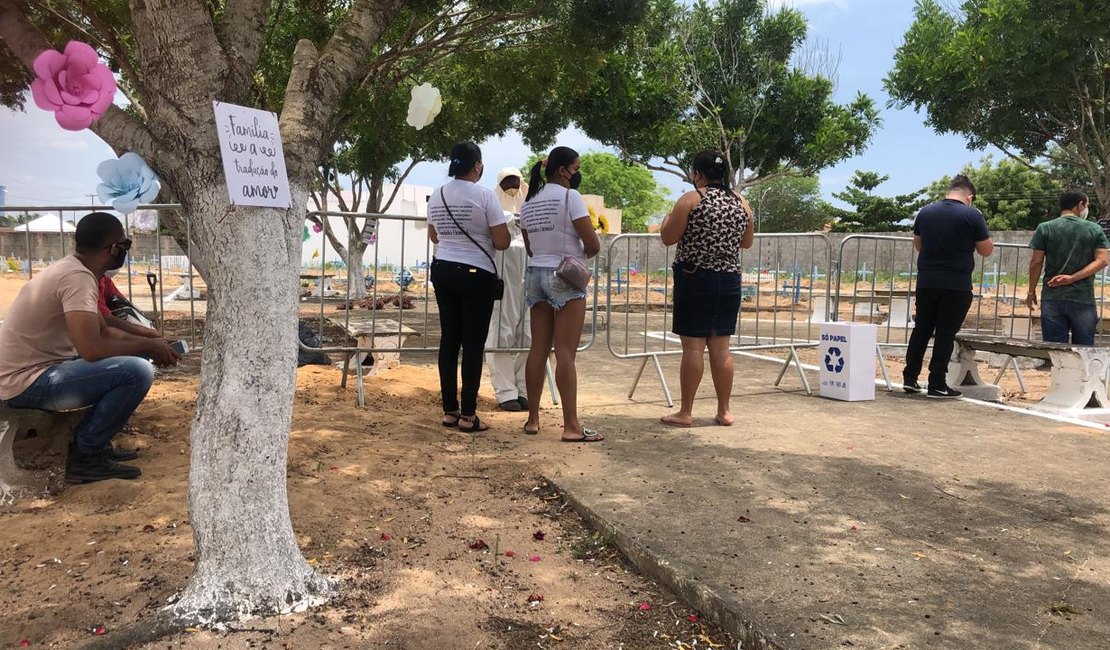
0, 330, 735, 649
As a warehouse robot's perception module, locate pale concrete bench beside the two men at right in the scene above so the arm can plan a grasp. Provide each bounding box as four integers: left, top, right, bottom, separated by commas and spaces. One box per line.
948, 334, 1110, 415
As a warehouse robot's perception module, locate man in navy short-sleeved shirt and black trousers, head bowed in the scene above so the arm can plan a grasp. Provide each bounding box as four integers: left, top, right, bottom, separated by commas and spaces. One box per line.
902, 174, 995, 398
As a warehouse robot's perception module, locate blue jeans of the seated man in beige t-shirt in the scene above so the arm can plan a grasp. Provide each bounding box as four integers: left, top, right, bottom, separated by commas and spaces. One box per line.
8, 356, 154, 454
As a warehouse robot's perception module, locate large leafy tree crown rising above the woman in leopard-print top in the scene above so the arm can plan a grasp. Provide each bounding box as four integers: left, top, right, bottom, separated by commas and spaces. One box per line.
572, 0, 879, 187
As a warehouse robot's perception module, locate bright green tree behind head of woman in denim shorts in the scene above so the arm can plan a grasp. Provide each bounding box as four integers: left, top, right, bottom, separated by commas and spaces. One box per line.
521, 152, 670, 233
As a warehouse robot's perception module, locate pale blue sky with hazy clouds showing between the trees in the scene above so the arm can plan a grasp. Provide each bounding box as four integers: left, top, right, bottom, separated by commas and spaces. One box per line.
0, 0, 1003, 212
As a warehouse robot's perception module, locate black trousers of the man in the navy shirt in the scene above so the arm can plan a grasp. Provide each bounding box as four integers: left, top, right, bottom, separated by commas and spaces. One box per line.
902, 288, 971, 388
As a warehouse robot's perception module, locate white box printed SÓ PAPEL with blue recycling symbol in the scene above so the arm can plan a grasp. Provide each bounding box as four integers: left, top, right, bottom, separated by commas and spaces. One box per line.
817, 323, 879, 402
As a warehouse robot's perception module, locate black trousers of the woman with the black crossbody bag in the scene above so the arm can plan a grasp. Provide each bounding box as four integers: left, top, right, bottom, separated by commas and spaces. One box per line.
431, 260, 497, 415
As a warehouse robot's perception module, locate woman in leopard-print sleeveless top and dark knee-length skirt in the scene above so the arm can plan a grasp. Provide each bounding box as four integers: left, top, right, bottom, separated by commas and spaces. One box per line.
659, 151, 755, 427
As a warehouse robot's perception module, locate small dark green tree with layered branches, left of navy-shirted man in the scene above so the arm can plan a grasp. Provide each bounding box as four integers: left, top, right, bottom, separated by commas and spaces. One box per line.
833, 171, 927, 233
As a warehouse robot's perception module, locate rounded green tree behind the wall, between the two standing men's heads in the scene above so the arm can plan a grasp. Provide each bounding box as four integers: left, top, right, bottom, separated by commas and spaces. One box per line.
926, 155, 1064, 231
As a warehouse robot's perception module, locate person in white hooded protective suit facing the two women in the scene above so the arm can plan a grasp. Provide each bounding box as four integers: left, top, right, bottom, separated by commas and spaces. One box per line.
486, 167, 532, 413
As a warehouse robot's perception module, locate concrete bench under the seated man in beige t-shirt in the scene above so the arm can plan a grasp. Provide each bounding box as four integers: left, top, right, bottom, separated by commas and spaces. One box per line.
0, 403, 84, 505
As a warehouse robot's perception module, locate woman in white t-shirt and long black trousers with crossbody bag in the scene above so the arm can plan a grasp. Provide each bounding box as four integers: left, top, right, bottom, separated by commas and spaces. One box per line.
427, 142, 509, 431
